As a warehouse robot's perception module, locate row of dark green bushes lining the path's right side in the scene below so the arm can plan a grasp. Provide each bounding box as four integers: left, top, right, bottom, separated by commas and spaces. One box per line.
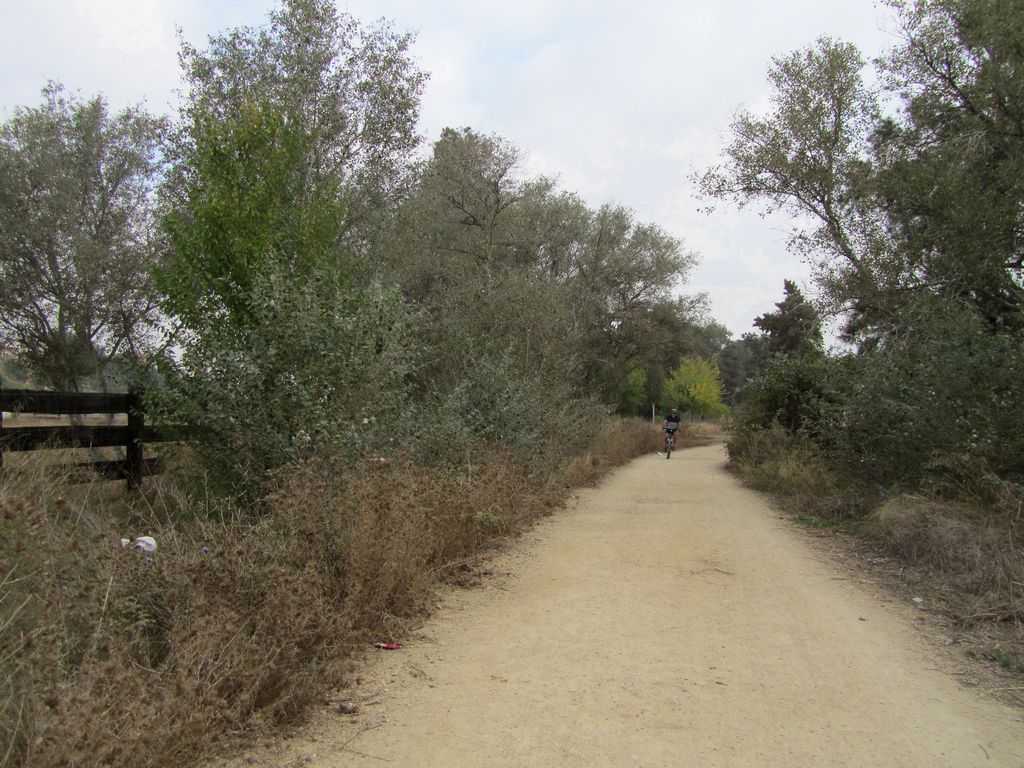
738, 290, 1024, 499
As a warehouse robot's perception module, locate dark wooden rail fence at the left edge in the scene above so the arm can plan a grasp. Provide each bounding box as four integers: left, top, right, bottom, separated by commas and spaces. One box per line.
0, 387, 163, 489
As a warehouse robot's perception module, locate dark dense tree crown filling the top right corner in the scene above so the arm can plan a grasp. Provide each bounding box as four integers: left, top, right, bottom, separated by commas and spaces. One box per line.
873, 0, 1024, 330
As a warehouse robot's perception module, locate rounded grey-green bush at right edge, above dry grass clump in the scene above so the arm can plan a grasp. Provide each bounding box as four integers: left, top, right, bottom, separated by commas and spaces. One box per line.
817, 304, 1024, 485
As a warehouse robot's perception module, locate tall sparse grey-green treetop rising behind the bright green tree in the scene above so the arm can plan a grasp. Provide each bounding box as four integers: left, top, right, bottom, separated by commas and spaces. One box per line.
167, 0, 426, 247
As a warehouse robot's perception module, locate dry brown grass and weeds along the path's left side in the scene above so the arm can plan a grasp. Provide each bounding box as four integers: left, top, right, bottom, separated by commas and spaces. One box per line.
0, 423, 650, 768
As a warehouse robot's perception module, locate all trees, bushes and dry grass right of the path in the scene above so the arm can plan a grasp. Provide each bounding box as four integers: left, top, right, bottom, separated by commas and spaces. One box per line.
701, 0, 1024, 666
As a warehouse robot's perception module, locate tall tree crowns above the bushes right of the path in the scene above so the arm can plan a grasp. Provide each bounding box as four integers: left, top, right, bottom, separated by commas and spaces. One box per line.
701, 0, 1024, 344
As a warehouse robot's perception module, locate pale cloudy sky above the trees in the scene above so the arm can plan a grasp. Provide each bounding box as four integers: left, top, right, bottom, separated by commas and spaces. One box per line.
0, 0, 898, 337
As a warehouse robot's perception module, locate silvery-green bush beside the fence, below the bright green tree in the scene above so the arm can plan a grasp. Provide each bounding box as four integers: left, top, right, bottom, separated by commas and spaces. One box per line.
157, 270, 419, 500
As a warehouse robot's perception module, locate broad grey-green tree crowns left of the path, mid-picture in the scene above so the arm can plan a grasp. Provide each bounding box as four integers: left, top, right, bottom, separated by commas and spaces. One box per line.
374, 128, 696, 401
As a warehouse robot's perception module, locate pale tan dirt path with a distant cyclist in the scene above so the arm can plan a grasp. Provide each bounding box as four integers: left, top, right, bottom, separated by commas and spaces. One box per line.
230, 446, 1024, 768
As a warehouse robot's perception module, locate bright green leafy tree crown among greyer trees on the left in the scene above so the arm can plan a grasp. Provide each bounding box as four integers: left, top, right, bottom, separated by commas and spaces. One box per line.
157, 102, 345, 330
